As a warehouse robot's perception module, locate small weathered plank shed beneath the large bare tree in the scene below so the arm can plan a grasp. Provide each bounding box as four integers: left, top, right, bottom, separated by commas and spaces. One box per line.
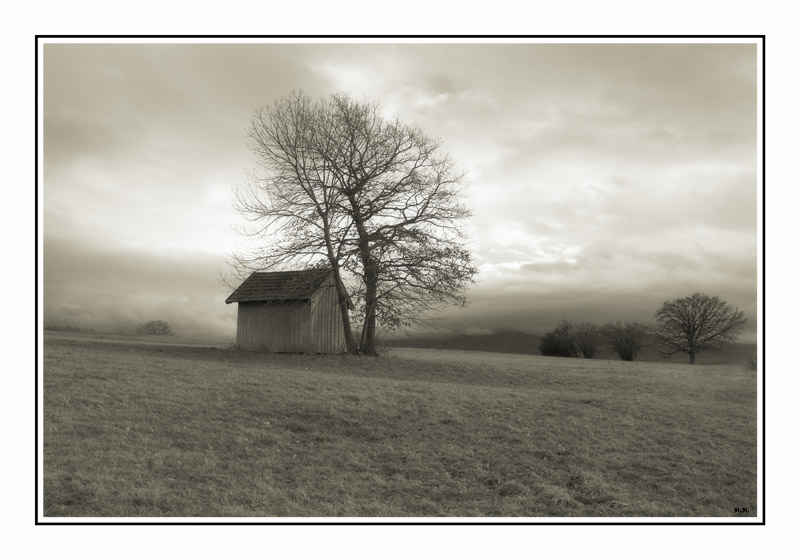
225, 269, 346, 354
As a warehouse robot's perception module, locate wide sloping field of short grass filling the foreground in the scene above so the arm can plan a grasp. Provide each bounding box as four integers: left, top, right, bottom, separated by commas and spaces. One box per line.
40, 332, 757, 517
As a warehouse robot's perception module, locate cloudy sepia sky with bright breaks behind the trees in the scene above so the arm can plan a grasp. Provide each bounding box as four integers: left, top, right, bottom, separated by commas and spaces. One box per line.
39, 42, 760, 342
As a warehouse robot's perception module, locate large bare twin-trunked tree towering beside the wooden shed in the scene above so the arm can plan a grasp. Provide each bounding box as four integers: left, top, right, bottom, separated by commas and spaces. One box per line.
234, 93, 477, 355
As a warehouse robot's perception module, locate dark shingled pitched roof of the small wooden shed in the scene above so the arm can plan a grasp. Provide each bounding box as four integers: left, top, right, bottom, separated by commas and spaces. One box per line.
225, 268, 331, 303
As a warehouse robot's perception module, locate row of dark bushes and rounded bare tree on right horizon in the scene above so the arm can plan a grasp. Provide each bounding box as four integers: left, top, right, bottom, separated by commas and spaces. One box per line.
539, 293, 746, 364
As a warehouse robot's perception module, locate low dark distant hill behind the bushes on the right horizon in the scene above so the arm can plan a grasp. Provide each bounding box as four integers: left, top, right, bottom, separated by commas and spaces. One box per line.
386, 329, 756, 365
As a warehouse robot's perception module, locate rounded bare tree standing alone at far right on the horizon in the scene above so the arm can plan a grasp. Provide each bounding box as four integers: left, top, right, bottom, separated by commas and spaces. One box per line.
654, 293, 747, 364
